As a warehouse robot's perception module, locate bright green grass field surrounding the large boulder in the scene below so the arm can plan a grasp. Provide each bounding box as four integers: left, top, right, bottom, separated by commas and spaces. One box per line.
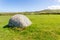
0, 15, 60, 40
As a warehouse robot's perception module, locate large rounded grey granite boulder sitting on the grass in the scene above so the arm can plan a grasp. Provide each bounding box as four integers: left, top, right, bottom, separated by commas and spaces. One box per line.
8, 14, 32, 28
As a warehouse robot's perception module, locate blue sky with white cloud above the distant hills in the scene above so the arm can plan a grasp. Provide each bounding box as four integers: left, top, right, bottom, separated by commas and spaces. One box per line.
0, 0, 60, 12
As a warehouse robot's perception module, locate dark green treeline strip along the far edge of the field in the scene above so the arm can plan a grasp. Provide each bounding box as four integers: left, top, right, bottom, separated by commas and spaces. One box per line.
0, 12, 60, 16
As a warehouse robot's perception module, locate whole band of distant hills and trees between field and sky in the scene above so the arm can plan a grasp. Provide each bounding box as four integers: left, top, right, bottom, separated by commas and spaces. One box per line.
0, 9, 60, 15
